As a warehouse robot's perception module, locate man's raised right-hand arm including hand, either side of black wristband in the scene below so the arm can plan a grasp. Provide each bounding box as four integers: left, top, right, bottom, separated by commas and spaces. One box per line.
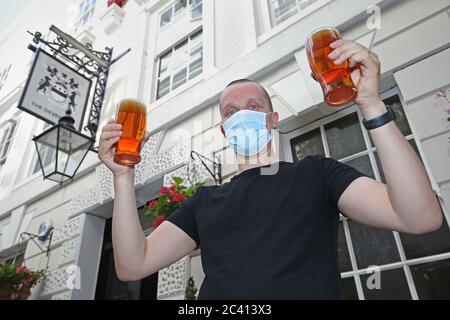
329, 40, 443, 234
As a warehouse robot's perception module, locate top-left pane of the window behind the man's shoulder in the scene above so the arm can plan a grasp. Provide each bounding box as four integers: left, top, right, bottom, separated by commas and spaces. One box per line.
291, 129, 325, 161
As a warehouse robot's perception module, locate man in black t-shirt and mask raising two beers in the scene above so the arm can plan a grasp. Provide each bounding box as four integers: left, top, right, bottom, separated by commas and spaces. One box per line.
99, 40, 442, 299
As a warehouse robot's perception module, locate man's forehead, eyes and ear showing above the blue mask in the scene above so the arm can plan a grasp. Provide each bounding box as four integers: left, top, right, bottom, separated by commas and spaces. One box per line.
220, 82, 278, 133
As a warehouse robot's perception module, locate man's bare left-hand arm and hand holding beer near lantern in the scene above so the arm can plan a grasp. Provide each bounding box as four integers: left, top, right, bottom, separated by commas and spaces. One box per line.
98, 120, 196, 281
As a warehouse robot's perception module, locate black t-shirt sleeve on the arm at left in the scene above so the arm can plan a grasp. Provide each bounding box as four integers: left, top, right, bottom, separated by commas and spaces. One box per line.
167, 191, 200, 247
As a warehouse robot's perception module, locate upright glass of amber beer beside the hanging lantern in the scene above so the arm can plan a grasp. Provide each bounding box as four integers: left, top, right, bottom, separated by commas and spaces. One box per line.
114, 99, 147, 166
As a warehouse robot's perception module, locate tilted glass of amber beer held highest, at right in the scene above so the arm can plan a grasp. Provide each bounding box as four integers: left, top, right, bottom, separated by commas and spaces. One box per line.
306, 27, 358, 107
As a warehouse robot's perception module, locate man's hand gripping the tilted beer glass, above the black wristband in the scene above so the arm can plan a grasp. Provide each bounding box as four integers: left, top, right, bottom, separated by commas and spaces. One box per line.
328, 39, 385, 113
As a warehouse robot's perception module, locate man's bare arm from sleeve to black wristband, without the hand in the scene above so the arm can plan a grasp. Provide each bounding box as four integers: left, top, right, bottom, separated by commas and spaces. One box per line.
338, 104, 442, 234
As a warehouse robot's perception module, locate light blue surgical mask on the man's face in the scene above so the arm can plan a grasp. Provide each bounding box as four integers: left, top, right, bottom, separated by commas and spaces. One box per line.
223, 110, 272, 157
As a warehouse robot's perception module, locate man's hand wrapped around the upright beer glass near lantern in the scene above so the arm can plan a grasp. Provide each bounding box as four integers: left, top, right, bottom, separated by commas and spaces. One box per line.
98, 120, 149, 176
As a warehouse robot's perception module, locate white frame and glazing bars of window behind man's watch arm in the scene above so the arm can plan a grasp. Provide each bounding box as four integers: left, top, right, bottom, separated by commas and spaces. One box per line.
282, 87, 450, 300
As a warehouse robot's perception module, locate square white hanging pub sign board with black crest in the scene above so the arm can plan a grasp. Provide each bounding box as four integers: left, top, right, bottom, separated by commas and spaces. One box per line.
18, 49, 91, 131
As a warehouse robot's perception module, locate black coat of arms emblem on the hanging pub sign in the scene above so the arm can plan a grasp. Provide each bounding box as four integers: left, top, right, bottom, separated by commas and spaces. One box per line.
36, 65, 80, 113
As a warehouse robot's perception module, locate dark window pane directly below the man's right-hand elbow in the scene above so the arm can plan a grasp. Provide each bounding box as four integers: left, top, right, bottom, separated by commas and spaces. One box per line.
400, 215, 450, 260
